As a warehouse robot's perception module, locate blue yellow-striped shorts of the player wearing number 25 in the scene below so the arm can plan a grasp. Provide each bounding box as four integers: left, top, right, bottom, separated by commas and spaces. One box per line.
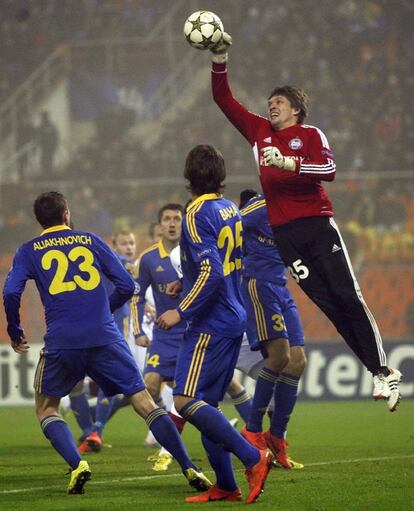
173, 330, 242, 406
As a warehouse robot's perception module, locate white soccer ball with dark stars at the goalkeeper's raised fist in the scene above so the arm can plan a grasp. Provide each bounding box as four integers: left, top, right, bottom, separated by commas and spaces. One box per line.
184, 11, 224, 50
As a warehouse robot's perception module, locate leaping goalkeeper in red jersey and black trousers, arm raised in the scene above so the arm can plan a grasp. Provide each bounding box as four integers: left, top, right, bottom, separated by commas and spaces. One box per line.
207, 34, 401, 411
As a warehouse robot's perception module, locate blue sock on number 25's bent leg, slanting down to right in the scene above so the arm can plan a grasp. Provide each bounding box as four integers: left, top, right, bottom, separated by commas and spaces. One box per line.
180, 399, 260, 468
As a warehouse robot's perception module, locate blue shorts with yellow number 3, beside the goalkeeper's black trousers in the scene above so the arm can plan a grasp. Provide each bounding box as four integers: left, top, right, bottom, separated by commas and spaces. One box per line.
242, 277, 305, 349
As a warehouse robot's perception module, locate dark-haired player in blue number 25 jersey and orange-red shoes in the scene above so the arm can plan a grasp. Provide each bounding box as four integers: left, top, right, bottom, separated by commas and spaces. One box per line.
158, 145, 270, 503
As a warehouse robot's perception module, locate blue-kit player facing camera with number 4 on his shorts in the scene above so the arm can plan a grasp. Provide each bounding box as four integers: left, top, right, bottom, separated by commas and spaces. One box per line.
131, 204, 185, 471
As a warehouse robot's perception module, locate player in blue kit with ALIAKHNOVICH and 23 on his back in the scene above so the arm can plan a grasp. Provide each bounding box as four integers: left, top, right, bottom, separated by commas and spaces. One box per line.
3, 192, 211, 494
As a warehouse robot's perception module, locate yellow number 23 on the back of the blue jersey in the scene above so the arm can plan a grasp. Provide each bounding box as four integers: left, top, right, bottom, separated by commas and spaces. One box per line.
42, 247, 101, 295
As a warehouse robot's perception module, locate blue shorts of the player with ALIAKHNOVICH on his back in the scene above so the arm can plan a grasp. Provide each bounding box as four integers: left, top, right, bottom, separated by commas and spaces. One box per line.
34, 341, 145, 397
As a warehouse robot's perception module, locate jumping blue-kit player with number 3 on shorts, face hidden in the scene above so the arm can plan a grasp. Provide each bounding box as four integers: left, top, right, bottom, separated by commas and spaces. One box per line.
240, 190, 306, 469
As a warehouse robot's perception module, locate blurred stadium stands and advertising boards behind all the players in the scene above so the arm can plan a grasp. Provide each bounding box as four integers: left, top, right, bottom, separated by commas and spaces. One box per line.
0, 0, 414, 404
